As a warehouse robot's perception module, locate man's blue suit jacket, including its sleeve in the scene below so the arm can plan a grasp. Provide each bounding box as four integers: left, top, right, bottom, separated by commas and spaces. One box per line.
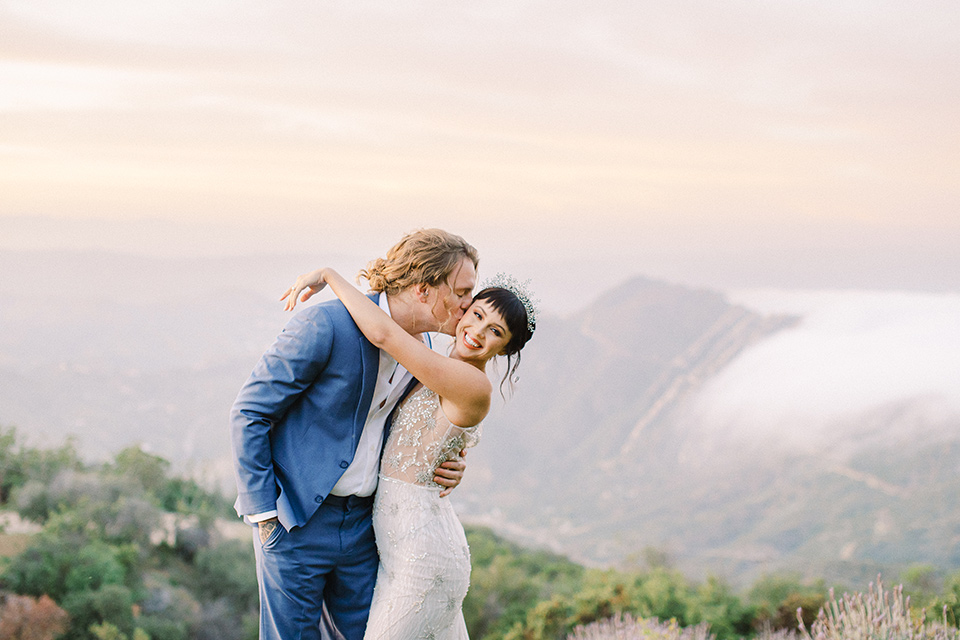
230, 295, 389, 530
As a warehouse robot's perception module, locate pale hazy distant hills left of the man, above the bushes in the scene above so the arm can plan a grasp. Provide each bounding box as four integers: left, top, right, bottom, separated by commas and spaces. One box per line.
0, 252, 344, 464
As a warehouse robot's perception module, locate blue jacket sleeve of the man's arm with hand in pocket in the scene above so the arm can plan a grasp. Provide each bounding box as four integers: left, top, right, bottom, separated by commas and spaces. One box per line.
230, 306, 333, 515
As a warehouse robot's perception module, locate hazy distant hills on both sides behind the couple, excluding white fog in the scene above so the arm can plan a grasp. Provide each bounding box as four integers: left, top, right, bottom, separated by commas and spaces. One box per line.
0, 252, 960, 583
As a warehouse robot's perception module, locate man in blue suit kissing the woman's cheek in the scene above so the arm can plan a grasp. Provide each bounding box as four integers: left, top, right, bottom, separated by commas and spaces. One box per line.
230, 229, 478, 640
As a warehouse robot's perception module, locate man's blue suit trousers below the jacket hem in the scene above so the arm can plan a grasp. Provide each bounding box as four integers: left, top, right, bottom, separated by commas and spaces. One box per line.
253, 496, 379, 640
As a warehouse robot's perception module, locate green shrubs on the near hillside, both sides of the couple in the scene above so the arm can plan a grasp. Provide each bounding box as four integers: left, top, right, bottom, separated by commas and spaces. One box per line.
0, 429, 960, 640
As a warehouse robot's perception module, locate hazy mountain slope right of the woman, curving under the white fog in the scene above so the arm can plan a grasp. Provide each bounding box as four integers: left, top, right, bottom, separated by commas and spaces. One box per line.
461, 279, 960, 582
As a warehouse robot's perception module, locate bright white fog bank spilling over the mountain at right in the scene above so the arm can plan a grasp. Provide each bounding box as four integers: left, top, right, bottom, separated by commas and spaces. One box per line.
683, 290, 960, 457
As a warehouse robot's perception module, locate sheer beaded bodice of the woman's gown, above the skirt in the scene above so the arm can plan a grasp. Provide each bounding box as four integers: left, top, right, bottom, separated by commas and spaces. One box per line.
380, 387, 481, 489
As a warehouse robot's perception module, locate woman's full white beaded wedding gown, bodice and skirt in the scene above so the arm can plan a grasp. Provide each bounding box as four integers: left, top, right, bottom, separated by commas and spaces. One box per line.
364, 387, 480, 640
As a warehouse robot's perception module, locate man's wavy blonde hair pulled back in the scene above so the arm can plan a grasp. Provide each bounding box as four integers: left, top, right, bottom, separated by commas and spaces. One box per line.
358, 229, 480, 295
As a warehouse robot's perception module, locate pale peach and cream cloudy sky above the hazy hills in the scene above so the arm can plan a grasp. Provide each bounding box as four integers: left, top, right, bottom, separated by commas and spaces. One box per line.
0, 0, 960, 292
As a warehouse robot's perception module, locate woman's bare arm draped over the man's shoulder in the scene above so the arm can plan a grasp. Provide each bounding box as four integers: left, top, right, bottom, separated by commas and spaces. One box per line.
281, 269, 492, 426
